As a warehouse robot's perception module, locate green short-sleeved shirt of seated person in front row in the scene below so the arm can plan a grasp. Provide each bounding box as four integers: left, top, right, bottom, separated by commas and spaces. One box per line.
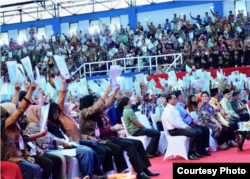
123, 107, 139, 135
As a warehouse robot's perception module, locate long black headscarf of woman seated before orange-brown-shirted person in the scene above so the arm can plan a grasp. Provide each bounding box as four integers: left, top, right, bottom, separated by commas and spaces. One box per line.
48, 103, 66, 138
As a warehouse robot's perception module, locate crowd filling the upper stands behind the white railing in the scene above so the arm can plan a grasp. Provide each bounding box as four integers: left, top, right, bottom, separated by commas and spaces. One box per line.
0, 10, 250, 83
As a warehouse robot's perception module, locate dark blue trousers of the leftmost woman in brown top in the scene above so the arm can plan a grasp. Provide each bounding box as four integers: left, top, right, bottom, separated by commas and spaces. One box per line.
17, 159, 42, 179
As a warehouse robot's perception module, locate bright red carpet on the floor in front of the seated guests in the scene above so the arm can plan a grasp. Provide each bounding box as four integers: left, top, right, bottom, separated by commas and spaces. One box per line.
147, 140, 250, 179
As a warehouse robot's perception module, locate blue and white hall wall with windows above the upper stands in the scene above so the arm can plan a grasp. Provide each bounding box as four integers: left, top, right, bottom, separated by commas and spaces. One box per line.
0, 0, 238, 39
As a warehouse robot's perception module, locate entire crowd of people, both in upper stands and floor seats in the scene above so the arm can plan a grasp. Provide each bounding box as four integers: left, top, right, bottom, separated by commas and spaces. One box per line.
0, 5, 250, 179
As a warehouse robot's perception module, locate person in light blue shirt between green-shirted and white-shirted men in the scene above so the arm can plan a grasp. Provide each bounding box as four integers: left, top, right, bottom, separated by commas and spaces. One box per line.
155, 93, 167, 131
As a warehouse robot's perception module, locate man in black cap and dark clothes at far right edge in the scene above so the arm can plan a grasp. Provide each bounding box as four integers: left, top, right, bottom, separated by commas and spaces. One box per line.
231, 91, 250, 121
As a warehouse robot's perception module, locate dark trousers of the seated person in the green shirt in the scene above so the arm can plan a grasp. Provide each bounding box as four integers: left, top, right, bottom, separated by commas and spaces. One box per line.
133, 128, 161, 154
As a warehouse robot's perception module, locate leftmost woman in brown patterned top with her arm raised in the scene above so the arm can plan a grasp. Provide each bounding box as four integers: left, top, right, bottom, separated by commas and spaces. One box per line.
0, 82, 46, 179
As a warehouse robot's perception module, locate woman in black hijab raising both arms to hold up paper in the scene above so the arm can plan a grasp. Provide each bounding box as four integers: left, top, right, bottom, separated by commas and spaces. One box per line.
79, 86, 119, 172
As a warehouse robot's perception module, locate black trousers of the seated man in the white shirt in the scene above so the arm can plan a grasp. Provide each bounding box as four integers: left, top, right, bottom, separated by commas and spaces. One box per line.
169, 128, 202, 153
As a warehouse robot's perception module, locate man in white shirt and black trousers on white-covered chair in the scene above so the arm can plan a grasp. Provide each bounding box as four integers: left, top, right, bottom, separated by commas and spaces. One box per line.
161, 93, 207, 160
